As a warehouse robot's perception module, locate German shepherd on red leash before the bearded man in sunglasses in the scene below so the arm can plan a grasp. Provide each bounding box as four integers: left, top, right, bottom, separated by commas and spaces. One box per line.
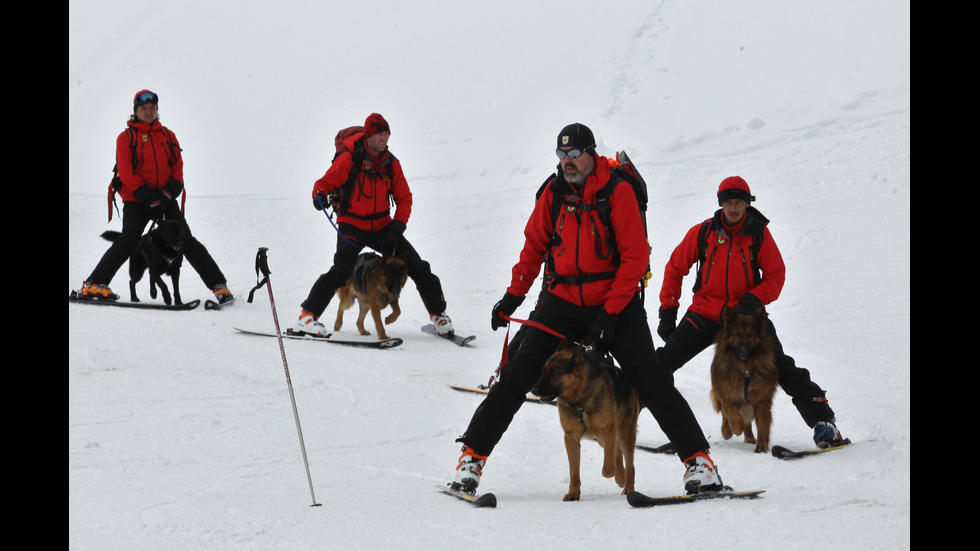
531, 339, 640, 501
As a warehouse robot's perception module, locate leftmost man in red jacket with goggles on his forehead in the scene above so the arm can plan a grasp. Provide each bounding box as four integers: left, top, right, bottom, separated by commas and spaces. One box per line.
79, 90, 233, 304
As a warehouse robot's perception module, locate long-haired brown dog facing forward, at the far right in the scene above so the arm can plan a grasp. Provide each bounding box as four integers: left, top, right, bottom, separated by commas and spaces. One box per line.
711, 308, 779, 453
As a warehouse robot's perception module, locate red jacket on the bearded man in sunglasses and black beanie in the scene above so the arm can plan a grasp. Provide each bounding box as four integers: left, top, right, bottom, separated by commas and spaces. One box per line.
507, 155, 650, 314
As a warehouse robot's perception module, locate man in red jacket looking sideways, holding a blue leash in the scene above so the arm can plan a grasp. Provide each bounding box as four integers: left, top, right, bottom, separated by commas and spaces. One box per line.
293, 113, 453, 336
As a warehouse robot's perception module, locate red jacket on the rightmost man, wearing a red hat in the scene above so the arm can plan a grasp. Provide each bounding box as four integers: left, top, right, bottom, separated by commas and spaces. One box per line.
660, 207, 786, 321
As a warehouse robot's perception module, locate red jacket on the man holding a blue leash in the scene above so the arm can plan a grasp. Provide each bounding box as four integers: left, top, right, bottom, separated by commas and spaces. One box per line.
313, 132, 412, 231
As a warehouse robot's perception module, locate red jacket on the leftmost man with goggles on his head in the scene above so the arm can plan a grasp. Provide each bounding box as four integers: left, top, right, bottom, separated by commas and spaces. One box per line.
116, 120, 184, 201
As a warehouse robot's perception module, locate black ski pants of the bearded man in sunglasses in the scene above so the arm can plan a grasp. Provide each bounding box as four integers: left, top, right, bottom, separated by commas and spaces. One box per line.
457, 292, 708, 460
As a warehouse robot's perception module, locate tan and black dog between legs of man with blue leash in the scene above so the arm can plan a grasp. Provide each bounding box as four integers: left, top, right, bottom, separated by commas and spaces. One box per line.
333, 253, 408, 340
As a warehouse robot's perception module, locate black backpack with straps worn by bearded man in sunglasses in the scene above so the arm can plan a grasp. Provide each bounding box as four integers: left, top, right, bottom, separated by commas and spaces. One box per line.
535, 151, 653, 298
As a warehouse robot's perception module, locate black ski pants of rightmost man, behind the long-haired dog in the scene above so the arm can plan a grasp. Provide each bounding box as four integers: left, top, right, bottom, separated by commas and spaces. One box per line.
657, 310, 834, 427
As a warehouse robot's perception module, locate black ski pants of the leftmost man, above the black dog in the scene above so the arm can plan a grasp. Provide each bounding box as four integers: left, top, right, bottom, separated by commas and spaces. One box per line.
85, 200, 227, 290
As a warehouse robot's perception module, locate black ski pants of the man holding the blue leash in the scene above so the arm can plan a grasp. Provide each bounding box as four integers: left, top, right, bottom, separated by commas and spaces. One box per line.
301, 224, 446, 318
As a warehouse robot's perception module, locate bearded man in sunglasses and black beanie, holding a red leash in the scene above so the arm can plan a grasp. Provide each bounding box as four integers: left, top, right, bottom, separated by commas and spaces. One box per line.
451, 124, 723, 493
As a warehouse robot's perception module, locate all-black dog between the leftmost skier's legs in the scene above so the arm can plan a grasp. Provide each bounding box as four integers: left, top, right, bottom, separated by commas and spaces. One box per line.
102, 220, 184, 306
